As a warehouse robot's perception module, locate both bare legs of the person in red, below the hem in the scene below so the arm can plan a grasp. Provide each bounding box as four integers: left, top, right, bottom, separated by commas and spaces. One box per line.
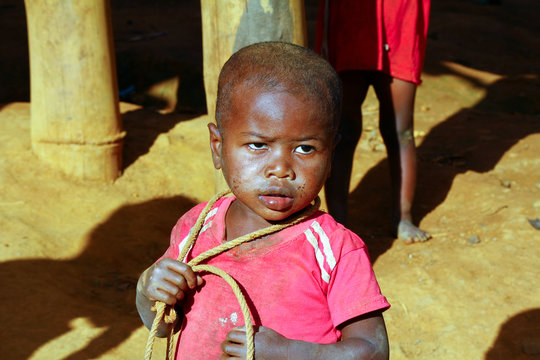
325, 71, 431, 243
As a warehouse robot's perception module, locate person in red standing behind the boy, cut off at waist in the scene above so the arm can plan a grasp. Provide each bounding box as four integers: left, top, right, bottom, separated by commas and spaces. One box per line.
315, 0, 431, 243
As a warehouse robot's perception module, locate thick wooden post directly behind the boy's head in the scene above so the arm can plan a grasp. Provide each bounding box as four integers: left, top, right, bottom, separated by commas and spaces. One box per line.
201, 0, 307, 191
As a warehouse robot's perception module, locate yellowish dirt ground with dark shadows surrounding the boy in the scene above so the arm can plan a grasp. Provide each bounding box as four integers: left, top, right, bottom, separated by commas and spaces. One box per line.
0, 0, 540, 360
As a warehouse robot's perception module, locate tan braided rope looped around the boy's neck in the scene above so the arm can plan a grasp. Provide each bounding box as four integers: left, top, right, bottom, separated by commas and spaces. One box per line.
144, 190, 321, 360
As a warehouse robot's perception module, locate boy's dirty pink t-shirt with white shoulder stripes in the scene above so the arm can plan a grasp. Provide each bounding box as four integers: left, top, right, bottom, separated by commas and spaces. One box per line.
164, 197, 390, 360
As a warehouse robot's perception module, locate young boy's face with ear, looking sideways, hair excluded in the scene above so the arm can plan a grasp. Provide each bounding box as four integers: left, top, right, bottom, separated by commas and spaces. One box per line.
209, 86, 334, 221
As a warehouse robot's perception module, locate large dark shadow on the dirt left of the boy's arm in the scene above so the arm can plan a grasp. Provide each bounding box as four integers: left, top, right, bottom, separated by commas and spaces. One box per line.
0, 196, 195, 360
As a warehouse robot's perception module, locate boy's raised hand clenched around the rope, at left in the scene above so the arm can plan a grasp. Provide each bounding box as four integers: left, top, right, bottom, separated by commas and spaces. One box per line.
139, 259, 203, 305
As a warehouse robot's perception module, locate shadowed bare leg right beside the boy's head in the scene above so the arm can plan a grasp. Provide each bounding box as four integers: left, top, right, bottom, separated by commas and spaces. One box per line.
325, 71, 369, 224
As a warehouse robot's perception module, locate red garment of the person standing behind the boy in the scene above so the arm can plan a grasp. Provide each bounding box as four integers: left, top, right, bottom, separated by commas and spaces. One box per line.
315, 0, 430, 84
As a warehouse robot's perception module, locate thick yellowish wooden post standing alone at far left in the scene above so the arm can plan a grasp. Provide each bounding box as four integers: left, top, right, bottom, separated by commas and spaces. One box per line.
25, 0, 125, 181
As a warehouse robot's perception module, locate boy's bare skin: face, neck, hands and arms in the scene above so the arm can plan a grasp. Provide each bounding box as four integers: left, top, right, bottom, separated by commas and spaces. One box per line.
137, 86, 388, 360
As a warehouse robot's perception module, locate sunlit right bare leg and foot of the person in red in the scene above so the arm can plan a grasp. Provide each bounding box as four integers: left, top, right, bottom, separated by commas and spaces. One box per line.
374, 73, 431, 243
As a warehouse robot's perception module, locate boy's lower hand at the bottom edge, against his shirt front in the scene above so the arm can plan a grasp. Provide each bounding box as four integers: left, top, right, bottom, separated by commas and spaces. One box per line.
220, 326, 290, 360
